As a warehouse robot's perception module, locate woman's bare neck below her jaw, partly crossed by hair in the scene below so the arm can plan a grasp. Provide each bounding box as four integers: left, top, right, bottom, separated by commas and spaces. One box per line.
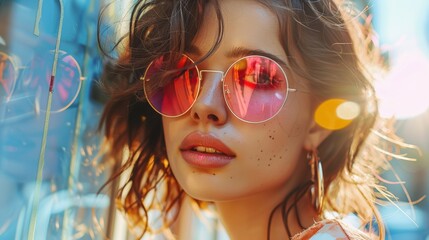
216, 191, 317, 240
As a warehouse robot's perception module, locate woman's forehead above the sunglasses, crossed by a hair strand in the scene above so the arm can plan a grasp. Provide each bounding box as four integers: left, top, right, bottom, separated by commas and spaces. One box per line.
192, 0, 286, 60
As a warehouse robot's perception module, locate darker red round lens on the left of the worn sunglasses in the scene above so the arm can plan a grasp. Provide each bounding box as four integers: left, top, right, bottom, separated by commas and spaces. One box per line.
143, 55, 199, 117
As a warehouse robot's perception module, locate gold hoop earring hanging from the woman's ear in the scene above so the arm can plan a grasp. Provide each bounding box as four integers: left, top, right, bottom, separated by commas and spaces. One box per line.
307, 150, 325, 213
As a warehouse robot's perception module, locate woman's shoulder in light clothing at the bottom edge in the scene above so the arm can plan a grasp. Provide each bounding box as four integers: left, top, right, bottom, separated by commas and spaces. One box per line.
292, 219, 374, 240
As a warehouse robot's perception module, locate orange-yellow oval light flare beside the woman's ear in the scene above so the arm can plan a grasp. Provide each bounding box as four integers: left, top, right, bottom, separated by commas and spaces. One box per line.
314, 99, 360, 130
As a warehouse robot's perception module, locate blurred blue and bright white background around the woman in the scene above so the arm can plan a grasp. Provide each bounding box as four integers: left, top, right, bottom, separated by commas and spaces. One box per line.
0, 0, 429, 240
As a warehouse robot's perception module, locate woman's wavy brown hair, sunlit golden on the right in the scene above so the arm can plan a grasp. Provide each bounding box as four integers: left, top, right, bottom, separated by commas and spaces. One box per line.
100, 0, 398, 238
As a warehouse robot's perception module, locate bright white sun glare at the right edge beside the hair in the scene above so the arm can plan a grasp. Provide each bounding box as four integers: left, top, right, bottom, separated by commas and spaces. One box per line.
375, 51, 429, 119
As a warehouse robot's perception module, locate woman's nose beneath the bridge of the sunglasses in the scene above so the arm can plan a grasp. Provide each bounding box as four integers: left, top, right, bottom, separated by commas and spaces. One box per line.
191, 71, 228, 125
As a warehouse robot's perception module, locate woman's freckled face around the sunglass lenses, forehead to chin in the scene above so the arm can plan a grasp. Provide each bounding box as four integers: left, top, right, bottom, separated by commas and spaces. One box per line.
163, 0, 313, 201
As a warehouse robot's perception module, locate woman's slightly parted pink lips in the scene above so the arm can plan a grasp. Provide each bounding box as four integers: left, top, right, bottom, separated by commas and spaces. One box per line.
180, 132, 235, 168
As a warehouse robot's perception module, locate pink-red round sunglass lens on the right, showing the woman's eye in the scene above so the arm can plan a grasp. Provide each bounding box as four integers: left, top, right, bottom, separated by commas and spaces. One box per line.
224, 56, 288, 123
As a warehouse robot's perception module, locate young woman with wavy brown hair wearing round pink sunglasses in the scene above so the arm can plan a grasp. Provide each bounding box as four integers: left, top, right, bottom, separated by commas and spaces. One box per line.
102, 0, 398, 240
